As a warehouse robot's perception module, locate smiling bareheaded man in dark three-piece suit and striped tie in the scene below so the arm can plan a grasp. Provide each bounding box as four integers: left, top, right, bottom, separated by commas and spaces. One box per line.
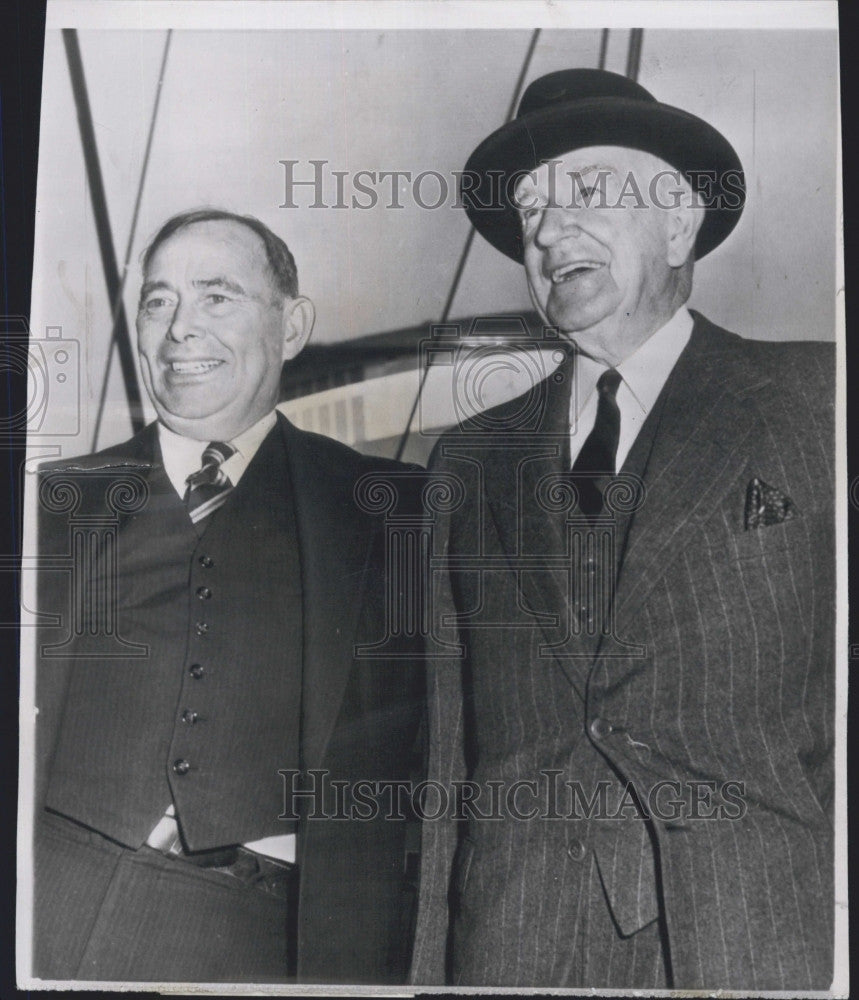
33, 209, 424, 983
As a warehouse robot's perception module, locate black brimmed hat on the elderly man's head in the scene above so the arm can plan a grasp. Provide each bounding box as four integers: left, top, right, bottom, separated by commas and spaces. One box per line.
461, 69, 746, 263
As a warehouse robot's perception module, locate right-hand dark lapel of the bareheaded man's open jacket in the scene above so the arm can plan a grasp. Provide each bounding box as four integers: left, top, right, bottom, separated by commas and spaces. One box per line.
278, 415, 373, 770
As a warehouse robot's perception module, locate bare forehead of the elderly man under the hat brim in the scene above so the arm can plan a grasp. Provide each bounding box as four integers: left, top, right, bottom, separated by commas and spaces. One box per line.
513, 146, 684, 207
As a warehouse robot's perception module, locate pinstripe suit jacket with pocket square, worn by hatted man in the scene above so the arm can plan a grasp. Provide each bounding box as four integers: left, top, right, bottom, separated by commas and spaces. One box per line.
412, 315, 835, 990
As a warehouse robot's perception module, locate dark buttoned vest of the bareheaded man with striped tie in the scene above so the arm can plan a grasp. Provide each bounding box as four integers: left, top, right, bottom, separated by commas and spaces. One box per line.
46, 429, 302, 851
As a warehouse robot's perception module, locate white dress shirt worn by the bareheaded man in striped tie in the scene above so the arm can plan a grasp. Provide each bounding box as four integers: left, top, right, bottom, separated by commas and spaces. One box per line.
147, 410, 296, 863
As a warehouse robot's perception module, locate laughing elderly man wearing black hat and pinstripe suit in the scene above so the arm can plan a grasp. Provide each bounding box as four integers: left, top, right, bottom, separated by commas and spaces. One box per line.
412, 70, 834, 990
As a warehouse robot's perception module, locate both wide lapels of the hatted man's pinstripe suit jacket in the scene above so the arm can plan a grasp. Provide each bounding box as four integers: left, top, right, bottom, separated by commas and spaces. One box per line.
483, 313, 768, 693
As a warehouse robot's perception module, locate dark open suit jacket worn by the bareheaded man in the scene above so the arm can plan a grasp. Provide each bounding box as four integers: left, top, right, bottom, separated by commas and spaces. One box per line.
37, 416, 424, 982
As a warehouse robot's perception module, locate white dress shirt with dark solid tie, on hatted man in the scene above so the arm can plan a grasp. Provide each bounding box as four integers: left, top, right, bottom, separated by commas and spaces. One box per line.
570, 306, 693, 471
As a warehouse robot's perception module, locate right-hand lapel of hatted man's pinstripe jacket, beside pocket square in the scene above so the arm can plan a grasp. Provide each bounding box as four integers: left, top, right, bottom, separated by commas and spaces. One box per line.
614, 315, 768, 634
